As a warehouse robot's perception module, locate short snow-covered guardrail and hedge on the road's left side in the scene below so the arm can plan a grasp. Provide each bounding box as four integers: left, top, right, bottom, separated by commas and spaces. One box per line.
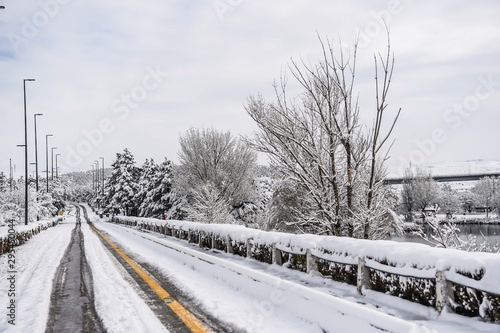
0, 216, 63, 255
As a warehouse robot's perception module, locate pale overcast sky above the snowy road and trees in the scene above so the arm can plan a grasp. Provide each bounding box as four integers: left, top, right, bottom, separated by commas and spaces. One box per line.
0, 0, 500, 173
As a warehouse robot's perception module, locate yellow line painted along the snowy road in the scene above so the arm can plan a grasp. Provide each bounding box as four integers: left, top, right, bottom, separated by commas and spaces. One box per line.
90, 226, 210, 333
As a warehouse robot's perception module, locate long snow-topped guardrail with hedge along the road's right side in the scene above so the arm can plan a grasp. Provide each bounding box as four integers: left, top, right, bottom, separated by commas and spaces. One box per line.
113, 216, 500, 322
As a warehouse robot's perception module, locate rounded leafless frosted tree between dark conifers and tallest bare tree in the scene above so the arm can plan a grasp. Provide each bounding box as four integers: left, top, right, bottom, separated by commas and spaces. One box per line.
175, 128, 256, 223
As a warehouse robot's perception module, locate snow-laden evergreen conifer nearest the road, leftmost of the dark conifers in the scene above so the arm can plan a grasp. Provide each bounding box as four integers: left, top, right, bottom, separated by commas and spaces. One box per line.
106, 148, 139, 213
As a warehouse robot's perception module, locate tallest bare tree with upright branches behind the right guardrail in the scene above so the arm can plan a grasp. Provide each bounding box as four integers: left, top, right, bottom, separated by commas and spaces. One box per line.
245, 38, 400, 238
